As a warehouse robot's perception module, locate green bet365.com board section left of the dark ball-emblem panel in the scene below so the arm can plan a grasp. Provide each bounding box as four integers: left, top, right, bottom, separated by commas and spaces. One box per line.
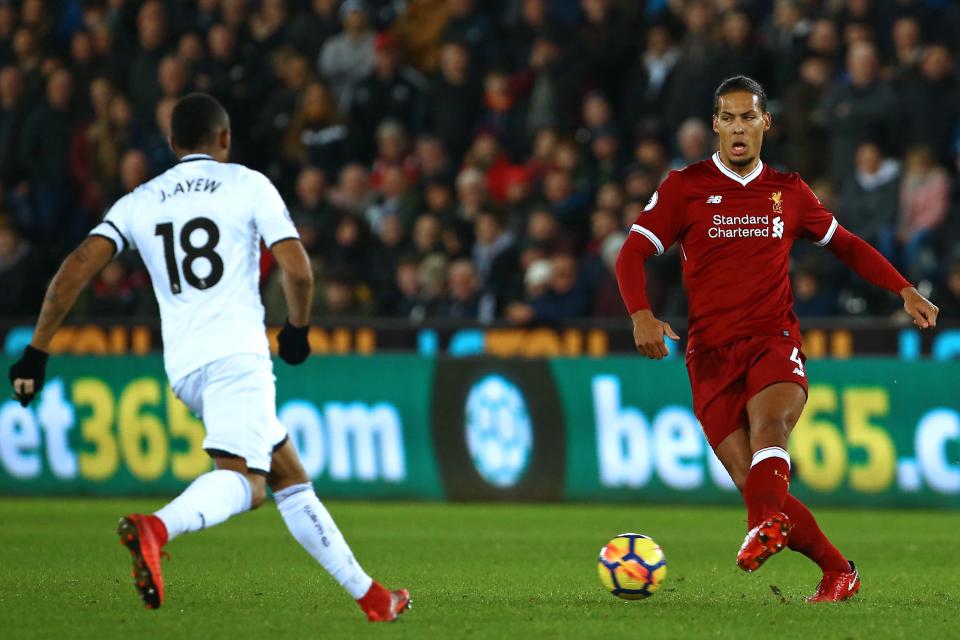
0, 356, 442, 499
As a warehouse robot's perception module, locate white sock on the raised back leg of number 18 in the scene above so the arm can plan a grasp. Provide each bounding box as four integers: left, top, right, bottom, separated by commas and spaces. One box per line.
154, 469, 252, 540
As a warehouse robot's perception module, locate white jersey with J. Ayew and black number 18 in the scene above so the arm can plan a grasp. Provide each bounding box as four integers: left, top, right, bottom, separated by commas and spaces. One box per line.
90, 154, 299, 384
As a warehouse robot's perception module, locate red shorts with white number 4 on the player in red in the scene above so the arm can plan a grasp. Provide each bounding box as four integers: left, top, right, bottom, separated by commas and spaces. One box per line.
687, 336, 807, 449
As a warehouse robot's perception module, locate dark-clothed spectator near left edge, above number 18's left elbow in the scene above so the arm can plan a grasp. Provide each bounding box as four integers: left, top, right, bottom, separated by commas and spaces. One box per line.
18, 69, 74, 242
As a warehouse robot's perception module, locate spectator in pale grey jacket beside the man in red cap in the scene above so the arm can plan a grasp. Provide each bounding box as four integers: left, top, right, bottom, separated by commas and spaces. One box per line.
317, 0, 374, 107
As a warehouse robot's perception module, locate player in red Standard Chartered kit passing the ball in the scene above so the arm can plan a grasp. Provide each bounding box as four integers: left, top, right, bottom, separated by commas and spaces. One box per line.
617, 76, 939, 602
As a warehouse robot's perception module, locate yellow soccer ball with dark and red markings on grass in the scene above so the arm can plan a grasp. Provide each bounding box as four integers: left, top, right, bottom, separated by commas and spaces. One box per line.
597, 533, 667, 600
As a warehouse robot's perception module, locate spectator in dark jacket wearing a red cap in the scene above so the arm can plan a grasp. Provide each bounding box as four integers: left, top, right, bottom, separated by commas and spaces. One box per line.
349, 33, 427, 157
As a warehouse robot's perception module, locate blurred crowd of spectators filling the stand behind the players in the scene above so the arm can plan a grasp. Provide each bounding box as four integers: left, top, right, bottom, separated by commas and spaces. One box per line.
0, 0, 960, 324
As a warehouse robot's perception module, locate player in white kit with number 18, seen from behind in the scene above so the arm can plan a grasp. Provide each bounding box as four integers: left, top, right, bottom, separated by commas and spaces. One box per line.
9, 93, 410, 622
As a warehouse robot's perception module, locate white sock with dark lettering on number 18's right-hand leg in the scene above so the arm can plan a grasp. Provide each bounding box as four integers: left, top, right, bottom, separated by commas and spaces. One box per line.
273, 482, 373, 600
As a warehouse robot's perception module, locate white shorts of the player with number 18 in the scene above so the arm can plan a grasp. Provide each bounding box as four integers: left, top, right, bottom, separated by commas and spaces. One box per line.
173, 353, 287, 473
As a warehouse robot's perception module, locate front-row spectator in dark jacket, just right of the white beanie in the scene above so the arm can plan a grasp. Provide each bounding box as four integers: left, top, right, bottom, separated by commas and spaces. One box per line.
506, 253, 591, 324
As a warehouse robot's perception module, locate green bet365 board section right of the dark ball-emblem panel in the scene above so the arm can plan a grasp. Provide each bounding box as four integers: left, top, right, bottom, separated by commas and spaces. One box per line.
551, 357, 960, 507
